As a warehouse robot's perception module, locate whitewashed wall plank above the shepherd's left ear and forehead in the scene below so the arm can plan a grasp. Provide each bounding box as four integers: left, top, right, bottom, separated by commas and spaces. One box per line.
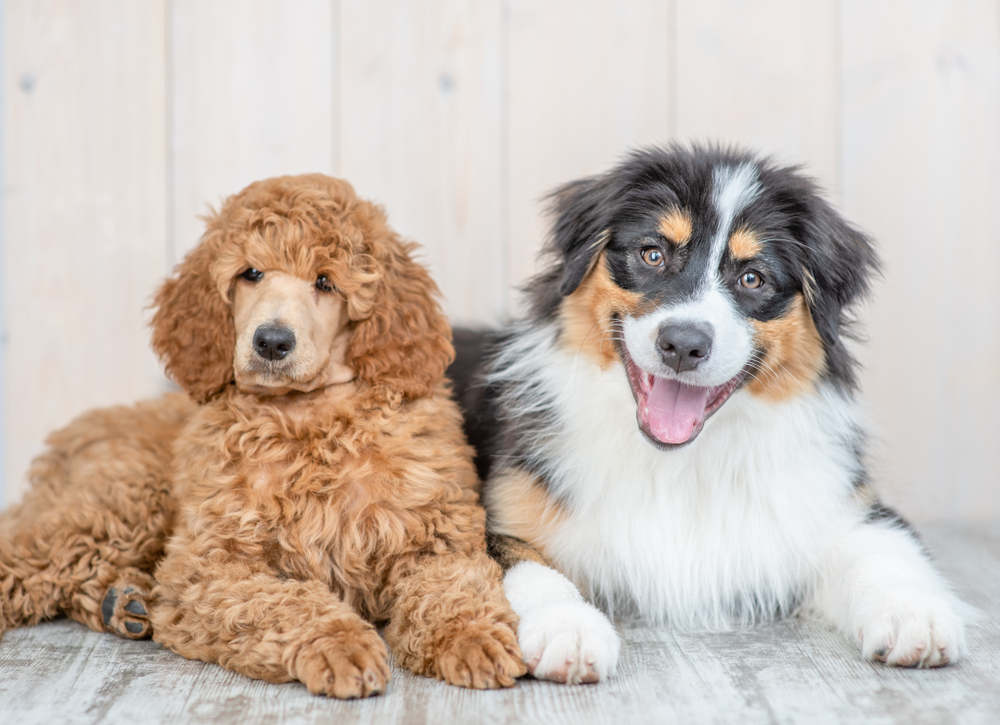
505, 0, 672, 300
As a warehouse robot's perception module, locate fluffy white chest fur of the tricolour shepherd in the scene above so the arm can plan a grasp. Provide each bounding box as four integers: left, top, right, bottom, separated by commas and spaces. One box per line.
524, 340, 862, 628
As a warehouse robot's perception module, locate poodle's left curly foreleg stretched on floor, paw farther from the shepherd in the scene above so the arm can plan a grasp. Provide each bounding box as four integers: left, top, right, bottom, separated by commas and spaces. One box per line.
153, 540, 389, 699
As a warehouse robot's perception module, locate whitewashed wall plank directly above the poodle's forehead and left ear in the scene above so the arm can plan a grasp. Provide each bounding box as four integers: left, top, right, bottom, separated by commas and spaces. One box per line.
169, 0, 337, 264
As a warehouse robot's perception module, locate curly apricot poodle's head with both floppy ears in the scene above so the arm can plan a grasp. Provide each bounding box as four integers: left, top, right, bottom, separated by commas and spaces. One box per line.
153, 174, 454, 402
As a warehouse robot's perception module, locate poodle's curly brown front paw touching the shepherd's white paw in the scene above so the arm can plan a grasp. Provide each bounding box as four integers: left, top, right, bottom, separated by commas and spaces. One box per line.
435, 622, 527, 690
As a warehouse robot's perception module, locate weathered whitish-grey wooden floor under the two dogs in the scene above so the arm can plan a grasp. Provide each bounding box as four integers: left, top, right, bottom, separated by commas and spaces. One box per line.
0, 525, 1000, 725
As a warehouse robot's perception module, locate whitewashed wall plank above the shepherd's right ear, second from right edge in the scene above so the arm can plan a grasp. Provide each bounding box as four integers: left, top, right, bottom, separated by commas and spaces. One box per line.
675, 0, 840, 194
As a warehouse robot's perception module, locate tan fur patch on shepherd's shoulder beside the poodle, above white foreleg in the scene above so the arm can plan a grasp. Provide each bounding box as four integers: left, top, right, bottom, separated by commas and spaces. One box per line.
484, 468, 568, 556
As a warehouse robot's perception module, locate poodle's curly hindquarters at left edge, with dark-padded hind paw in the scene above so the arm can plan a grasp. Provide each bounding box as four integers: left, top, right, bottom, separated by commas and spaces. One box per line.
0, 396, 193, 639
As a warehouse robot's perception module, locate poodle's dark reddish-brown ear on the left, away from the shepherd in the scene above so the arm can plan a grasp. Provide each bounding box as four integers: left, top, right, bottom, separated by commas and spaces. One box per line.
152, 232, 236, 403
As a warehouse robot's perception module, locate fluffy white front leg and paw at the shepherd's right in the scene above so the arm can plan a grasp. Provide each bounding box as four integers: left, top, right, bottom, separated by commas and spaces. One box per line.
806, 516, 968, 667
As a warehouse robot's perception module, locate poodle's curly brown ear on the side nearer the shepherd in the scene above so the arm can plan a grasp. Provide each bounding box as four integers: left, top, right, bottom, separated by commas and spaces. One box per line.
349, 240, 455, 400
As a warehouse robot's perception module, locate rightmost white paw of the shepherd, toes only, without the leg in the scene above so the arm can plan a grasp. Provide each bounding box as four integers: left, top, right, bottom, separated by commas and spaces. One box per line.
858, 593, 965, 667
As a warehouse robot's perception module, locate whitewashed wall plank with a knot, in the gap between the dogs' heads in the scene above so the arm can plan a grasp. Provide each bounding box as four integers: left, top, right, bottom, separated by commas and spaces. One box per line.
339, 0, 509, 324
